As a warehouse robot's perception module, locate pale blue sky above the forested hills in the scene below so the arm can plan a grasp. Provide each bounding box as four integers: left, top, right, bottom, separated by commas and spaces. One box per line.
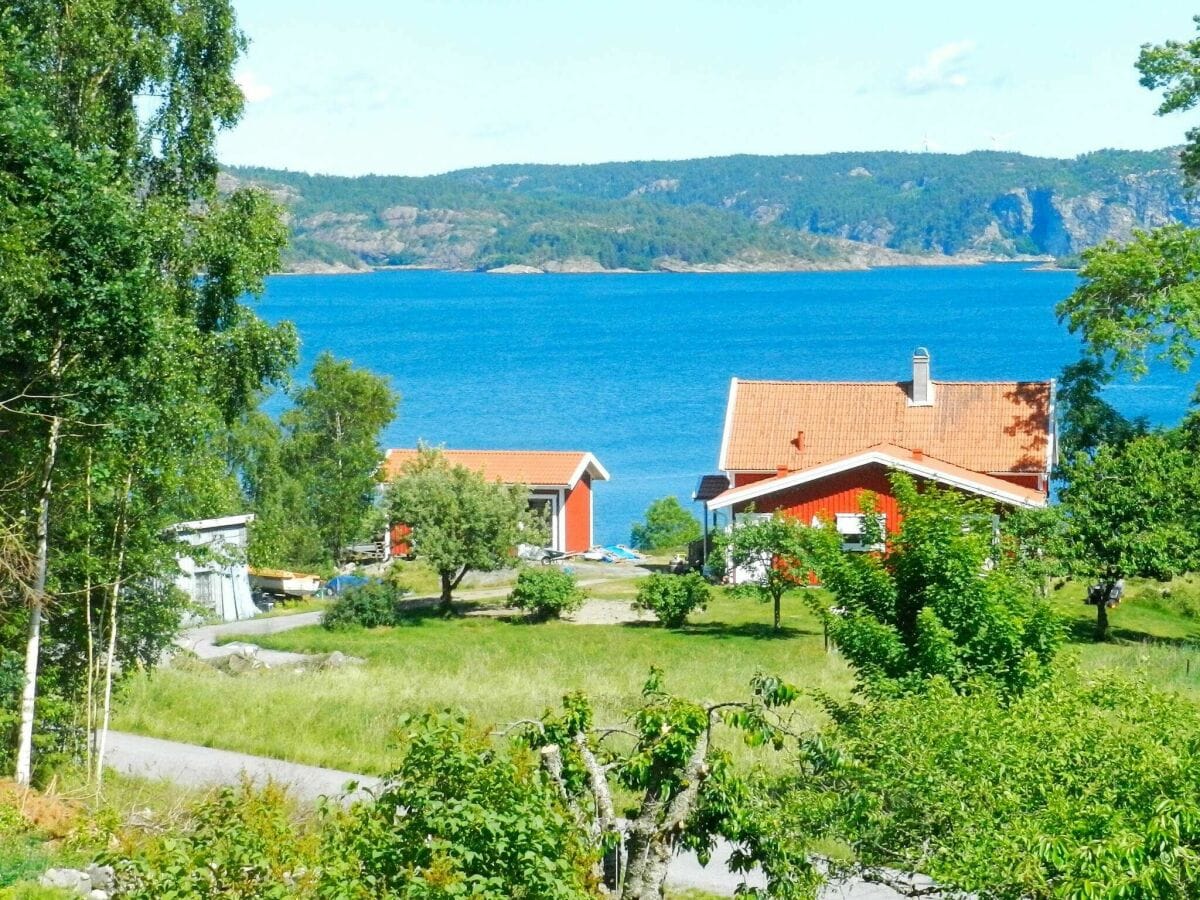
221, 0, 1198, 175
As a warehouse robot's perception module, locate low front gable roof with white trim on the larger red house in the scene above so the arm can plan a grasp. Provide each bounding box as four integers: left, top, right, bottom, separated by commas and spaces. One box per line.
708, 444, 1046, 509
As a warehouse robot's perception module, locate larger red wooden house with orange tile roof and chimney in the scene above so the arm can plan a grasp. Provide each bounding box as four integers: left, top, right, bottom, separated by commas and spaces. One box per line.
695, 348, 1055, 547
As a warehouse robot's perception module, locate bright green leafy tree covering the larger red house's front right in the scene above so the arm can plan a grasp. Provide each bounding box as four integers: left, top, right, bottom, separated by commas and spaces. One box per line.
815, 473, 1062, 692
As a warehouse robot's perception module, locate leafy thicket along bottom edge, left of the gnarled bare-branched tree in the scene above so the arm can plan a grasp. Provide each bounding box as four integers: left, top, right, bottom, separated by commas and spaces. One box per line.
108, 714, 596, 900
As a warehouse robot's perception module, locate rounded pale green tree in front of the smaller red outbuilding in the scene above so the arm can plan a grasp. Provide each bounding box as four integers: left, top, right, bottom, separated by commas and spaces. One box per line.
388, 448, 541, 612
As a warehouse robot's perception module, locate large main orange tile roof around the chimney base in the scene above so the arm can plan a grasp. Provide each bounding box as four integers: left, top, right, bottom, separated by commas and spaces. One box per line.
719, 379, 1052, 474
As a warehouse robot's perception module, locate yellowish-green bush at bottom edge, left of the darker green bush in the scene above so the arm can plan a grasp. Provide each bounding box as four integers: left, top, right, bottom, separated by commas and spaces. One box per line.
108, 781, 320, 900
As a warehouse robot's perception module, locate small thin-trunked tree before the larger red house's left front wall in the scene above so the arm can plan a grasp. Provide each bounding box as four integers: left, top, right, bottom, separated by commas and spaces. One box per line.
709, 512, 840, 631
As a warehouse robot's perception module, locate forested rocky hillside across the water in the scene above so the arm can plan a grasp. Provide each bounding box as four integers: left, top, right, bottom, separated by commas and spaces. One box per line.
226, 150, 1200, 271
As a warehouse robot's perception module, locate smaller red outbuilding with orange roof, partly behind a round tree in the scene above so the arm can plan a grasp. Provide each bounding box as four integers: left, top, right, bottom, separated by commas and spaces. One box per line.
384, 450, 608, 553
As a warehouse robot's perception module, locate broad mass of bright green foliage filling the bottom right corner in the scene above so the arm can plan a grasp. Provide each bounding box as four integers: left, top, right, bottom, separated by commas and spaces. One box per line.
770, 672, 1200, 898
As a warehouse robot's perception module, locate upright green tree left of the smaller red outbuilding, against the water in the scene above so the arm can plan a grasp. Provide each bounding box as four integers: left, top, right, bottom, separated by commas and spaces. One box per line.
281, 353, 400, 560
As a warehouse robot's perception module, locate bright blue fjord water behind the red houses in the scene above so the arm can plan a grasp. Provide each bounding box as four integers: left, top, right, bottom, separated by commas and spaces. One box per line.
258, 264, 1194, 542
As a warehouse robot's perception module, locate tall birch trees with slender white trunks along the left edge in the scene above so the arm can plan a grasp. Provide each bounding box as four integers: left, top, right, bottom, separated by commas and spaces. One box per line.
0, 0, 295, 782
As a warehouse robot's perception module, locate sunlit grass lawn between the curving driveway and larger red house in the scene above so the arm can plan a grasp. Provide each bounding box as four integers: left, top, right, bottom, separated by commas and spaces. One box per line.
115, 594, 851, 773
